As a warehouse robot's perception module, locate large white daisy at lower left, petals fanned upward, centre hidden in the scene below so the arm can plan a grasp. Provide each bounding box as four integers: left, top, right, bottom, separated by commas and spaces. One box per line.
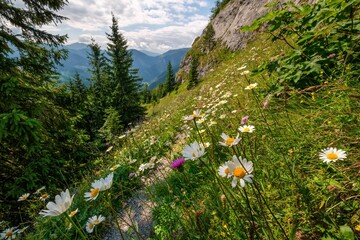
40, 189, 75, 217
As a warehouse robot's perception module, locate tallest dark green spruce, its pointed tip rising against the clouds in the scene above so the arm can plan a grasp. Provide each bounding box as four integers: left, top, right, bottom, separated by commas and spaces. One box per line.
107, 15, 145, 127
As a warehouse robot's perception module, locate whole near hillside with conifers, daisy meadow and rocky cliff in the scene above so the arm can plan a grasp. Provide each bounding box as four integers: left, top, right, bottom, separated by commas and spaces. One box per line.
0, 0, 360, 240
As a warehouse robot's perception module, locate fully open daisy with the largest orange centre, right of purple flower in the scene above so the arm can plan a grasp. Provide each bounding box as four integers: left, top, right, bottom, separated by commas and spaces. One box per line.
227, 155, 254, 188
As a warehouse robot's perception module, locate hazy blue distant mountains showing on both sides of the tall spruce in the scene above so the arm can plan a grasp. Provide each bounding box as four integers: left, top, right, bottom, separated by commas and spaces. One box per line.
58, 43, 189, 88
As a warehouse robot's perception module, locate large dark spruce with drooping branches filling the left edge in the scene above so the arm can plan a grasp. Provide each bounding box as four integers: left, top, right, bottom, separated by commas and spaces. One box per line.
0, 0, 95, 223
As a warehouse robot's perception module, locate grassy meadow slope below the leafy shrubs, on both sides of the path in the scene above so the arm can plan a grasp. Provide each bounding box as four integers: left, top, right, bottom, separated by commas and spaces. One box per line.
21, 30, 360, 239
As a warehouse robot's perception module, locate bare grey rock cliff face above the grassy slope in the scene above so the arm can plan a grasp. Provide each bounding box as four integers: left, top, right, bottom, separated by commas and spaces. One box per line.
177, 0, 316, 82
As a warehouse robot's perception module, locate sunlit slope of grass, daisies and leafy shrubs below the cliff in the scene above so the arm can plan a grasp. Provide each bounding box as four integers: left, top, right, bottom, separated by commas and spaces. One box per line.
1, 0, 360, 240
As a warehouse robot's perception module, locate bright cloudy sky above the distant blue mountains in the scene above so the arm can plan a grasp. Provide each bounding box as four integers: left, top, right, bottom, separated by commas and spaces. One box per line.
43, 0, 215, 53
